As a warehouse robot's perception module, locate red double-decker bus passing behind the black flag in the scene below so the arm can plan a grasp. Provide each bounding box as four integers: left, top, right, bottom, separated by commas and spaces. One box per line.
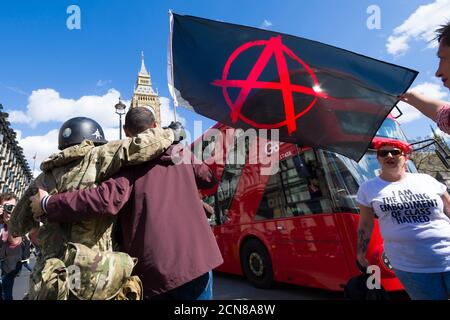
192, 117, 417, 291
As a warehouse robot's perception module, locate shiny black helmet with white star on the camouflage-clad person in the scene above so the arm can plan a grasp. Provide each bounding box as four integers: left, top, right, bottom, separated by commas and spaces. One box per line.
58, 117, 108, 150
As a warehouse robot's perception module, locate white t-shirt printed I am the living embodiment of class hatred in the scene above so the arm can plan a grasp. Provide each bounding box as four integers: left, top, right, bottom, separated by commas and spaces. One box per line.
357, 173, 450, 273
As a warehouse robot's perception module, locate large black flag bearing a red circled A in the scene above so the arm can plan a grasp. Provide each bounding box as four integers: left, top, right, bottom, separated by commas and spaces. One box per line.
168, 13, 417, 161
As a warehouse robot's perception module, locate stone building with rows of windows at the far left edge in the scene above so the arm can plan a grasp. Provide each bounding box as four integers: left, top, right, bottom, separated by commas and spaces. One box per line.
0, 104, 33, 198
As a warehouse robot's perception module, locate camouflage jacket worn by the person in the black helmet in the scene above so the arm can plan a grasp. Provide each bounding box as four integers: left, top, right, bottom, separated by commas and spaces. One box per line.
9, 128, 173, 272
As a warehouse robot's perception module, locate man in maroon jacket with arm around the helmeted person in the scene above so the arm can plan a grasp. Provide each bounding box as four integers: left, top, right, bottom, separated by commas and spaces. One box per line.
32, 107, 223, 300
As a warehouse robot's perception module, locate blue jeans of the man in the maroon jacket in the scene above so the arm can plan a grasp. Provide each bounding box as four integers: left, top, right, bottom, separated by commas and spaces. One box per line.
150, 271, 213, 300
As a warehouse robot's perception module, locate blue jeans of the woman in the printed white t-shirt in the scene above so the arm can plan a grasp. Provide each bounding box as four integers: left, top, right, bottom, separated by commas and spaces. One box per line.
394, 269, 450, 300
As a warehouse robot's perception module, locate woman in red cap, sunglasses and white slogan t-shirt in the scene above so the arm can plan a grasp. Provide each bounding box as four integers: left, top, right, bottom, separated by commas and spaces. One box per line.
357, 140, 450, 300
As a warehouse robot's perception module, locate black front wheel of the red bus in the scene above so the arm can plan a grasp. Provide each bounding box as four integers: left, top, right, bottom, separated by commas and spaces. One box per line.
241, 239, 273, 289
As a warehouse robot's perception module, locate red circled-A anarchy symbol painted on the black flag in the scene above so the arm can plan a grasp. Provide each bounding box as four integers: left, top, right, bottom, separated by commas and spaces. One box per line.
212, 36, 328, 134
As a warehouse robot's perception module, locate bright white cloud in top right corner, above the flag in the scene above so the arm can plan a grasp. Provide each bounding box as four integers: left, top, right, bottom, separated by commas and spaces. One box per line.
386, 0, 450, 56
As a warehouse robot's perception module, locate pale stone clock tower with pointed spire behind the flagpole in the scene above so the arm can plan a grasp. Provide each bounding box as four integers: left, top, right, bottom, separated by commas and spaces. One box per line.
130, 52, 161, 125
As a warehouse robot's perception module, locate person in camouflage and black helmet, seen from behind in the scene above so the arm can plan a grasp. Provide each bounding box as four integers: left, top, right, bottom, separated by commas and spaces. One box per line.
9, 117, 178, 299
